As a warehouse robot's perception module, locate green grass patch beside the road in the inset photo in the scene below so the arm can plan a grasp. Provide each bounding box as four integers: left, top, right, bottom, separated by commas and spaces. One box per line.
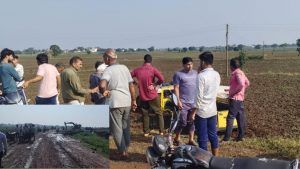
72, 133, 109, 157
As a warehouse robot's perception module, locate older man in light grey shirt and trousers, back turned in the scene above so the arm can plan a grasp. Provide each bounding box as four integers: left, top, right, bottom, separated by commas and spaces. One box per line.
99, 49, 136, 159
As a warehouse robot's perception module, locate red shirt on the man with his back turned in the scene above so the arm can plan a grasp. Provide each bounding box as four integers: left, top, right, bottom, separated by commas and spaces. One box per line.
131, 63, 164, 101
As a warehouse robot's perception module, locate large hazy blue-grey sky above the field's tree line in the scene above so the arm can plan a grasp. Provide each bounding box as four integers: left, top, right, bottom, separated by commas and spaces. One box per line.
0, 0, 300, 50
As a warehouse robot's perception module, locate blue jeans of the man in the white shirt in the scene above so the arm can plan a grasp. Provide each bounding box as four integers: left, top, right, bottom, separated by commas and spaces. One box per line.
194, 115, 219, 151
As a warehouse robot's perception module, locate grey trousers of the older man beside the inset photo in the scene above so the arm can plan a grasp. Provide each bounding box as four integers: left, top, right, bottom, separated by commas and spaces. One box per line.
109, 107, 131, 152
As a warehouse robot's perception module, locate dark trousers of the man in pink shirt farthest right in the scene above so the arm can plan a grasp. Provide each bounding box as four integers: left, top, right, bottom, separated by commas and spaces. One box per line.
223, 100, 245, 141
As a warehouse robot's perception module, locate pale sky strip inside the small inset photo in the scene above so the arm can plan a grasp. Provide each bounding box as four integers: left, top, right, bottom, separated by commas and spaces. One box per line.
0, 105, 109, 127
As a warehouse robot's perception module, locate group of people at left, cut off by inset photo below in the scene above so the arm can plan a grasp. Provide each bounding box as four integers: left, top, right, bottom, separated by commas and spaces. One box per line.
0, 48, 107, 105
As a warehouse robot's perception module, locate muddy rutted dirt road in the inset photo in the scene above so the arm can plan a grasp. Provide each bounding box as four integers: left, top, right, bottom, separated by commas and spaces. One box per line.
3, 131, 109, 168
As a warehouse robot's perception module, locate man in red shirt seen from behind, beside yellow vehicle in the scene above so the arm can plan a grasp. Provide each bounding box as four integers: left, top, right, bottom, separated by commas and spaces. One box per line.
131, 54, 164, 137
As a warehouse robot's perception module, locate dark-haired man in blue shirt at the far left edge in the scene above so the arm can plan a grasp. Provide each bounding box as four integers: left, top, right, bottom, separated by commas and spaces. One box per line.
0, 48, 23, 105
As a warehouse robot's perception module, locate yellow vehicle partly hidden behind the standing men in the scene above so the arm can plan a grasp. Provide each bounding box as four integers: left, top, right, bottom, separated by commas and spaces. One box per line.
158, 85, 237, 131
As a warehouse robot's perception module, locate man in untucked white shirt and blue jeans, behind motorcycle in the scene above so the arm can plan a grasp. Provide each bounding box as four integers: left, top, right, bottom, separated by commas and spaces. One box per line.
191, 52, 220, 156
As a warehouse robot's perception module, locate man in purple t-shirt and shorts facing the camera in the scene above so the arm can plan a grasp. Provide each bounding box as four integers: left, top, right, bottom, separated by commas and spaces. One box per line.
173, 57, 197, 145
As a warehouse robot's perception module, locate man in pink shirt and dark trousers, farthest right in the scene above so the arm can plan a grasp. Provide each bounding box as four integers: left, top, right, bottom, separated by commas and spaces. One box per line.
223, 58, 250, 141
